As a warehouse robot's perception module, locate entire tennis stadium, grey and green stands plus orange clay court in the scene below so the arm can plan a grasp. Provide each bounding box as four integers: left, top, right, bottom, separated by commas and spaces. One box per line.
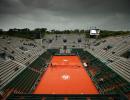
0, 30, 130, 100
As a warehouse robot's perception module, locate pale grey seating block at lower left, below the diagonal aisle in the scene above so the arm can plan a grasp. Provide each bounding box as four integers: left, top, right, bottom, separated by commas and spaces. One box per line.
0, 60, 26, 90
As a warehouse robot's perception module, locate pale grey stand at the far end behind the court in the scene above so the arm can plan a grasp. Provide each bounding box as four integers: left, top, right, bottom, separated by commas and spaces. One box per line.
43, 34, 86, 49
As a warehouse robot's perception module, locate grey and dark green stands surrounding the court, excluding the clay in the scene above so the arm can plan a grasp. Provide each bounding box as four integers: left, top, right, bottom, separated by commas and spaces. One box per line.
0, 34, 130, 99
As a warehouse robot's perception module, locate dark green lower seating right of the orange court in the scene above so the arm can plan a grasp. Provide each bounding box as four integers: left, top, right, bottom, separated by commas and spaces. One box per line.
78, 51, 130, 94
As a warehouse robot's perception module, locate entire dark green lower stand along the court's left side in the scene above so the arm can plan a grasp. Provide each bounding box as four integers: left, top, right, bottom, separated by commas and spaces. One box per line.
2, 52, 51, 97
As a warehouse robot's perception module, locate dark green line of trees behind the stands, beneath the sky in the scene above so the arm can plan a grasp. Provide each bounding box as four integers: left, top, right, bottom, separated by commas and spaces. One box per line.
0, 28, 130, 39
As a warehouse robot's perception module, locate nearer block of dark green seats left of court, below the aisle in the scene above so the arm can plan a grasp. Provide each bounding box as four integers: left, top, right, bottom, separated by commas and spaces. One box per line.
2, 68, 40, 93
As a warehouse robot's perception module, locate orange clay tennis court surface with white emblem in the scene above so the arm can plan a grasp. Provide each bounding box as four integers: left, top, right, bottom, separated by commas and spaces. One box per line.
34, 56, 98, 94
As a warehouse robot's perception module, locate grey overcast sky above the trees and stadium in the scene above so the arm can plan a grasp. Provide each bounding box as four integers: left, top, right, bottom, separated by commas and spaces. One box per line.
0, 0, 130, 30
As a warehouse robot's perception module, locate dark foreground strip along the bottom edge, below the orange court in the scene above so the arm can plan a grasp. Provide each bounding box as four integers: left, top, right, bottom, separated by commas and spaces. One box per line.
7, 94, 127, 100
